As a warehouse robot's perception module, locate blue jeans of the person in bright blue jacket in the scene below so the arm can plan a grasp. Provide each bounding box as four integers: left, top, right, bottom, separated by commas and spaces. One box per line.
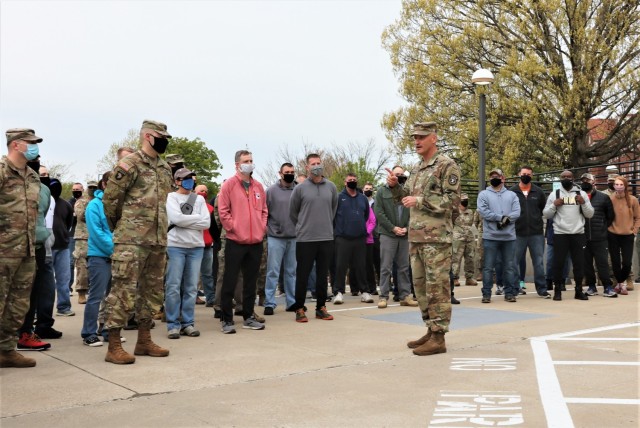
80, 256, 111, 339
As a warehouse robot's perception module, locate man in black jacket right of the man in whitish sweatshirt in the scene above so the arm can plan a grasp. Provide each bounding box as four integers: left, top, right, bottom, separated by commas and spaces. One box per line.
580, 173, 618, 297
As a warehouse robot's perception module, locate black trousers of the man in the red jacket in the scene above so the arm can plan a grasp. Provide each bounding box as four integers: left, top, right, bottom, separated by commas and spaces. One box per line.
221, 238, 262, 322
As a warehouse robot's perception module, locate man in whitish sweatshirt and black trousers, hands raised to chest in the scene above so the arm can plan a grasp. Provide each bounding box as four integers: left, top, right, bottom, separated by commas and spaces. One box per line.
542, 170, 594, 300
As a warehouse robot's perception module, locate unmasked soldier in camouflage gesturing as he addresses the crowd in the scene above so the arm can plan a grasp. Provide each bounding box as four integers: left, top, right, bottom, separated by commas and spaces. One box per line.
387, 122, 460, 355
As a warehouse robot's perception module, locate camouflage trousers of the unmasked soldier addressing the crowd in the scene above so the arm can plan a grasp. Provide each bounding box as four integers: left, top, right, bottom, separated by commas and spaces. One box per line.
409, 242, 452, 333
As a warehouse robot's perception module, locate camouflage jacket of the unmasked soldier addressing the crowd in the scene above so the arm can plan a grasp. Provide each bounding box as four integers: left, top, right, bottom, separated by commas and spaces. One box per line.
391, 152, 460, 244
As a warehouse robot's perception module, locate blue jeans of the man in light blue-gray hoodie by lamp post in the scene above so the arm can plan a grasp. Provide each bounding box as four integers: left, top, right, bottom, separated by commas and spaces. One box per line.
482, 239, 518, 297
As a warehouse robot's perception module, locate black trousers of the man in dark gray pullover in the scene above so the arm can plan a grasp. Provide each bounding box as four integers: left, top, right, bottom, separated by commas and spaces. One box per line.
290, 241, 333, 311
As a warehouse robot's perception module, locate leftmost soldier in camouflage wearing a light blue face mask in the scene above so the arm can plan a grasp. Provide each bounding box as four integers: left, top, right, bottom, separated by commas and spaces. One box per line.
0, 128, 42, 367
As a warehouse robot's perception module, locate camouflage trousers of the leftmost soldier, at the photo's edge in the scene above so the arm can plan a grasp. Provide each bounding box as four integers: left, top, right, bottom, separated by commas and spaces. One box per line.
0, 257, 36, 351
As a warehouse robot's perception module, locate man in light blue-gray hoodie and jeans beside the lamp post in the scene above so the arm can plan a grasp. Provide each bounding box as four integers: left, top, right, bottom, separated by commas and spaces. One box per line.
478, 168, 520, 303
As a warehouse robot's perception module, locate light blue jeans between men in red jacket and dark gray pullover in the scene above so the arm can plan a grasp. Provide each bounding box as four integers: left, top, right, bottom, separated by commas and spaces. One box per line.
264, 236, 296, 308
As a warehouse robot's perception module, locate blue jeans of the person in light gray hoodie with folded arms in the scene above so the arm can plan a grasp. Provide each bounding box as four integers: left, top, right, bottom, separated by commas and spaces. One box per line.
164, 247, 204, 330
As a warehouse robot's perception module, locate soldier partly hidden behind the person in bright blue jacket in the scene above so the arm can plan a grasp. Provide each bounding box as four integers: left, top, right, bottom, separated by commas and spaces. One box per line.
73, 181, 98, 303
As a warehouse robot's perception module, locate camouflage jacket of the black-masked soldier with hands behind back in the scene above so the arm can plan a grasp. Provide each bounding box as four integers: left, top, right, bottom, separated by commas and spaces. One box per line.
102, 150, 171, 246
